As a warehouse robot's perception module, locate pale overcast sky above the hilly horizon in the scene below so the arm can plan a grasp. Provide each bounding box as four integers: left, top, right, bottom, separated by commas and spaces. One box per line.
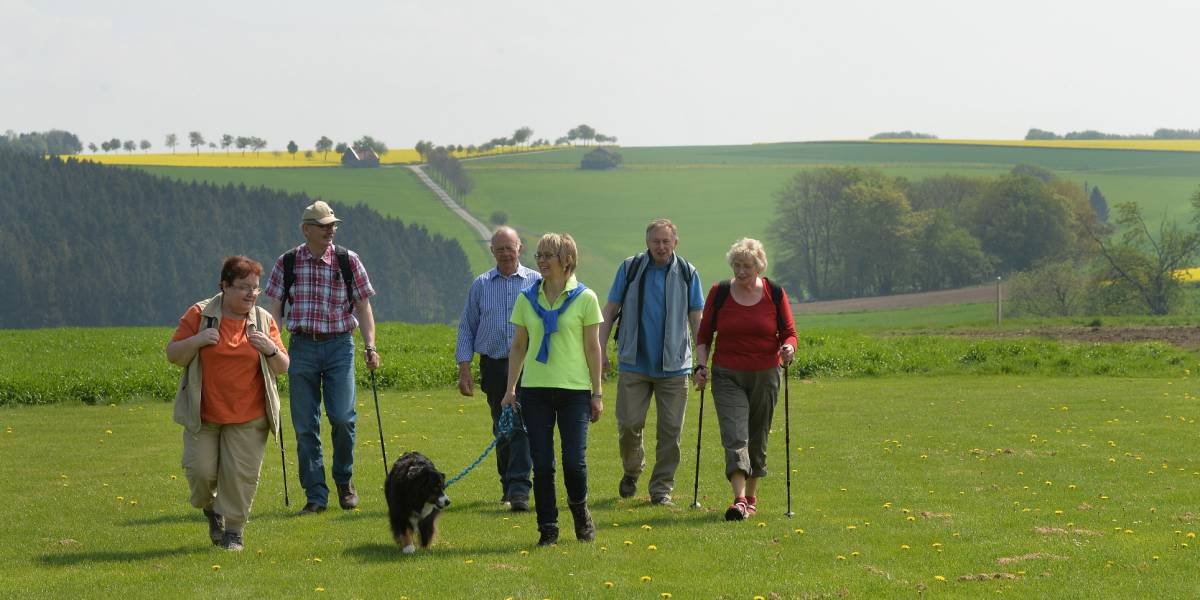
0, 0, 1200, 148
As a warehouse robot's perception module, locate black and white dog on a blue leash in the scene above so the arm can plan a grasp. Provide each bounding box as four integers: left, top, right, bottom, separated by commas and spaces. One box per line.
384, 452, 450, 554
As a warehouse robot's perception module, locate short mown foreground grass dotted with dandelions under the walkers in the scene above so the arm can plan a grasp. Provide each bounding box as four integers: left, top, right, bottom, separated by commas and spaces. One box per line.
0, 377, 1200, 599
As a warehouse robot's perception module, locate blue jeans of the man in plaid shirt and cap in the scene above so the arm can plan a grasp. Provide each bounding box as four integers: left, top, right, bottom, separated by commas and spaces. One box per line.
288, 334, 358, 506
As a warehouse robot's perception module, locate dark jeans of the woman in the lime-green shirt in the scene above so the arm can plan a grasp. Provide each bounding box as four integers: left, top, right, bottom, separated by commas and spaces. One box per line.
521, 388, 592, 527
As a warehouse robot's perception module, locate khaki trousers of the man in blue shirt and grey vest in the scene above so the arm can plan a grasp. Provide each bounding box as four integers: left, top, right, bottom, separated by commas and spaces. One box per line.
617, 371, 688, 499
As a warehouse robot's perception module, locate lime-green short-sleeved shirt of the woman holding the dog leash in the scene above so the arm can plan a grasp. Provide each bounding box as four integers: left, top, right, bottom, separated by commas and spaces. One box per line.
510, 275, 604, 390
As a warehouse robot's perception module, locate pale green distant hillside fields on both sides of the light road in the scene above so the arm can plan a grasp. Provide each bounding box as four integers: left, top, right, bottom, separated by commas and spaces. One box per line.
131, 142, 1200, 300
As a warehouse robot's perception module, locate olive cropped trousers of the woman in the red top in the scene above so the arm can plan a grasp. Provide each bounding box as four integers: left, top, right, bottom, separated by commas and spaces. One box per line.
712, 365, 781, 479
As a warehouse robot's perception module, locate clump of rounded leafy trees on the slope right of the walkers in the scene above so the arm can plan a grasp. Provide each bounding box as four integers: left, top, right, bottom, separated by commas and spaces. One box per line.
769, 167, 1096, 299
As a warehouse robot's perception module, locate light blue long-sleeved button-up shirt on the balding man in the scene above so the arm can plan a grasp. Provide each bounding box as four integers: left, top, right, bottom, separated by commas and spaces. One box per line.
454, 264, 541, 362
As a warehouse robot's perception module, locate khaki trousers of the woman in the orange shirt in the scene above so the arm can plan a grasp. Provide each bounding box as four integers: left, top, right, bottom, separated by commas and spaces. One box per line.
184, 416, 266, 533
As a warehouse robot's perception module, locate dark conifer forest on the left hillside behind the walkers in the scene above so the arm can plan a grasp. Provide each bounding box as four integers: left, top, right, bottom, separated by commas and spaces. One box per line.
0, 149, 470, 328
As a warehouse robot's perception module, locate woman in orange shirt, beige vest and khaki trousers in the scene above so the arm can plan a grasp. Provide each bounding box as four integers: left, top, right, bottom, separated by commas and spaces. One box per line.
167, 256, 288, 551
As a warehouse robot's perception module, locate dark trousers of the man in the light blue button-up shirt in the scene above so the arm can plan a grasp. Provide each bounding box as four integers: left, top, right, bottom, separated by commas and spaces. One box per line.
479, 354, 533, 499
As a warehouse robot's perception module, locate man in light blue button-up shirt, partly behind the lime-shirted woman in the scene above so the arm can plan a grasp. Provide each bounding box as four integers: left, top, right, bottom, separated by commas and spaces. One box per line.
455, 226, 541, 512
